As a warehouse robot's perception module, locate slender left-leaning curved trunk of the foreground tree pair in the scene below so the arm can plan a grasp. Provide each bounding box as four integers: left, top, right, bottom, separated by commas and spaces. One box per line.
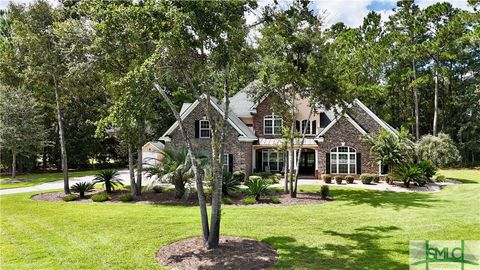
154, 83, 210, 245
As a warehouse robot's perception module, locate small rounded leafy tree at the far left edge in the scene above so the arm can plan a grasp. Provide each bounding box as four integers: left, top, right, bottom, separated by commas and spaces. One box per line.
0, 84, 47, 179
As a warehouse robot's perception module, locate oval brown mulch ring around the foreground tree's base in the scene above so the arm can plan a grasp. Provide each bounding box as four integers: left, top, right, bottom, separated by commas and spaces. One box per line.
156, 236, 278, 270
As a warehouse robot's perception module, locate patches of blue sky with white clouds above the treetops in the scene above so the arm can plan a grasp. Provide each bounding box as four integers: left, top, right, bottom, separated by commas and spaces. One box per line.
0, 0, 468, 27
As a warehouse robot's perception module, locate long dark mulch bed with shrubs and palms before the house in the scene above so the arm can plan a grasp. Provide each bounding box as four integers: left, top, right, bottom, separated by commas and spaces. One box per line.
31, 190, 327, 207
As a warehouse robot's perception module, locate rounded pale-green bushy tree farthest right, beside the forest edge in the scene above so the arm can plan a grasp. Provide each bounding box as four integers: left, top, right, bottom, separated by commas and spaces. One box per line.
416, 133, 460, 167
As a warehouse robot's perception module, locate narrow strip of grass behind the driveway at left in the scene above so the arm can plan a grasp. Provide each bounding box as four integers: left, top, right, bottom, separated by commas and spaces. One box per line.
0, 170, 110, 189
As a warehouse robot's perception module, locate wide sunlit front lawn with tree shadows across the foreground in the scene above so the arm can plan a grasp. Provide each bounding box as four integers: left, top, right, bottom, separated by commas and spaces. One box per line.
0, 184, 480, 269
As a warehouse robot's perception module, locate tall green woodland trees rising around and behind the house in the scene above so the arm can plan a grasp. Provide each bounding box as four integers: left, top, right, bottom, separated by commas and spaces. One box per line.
0, 0, 480, 175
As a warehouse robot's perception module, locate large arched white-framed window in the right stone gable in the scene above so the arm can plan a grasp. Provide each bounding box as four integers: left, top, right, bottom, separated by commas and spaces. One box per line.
330, 146, 357, 174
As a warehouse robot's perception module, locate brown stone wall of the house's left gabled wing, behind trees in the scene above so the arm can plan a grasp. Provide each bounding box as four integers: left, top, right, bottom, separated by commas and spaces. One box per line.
165, 104, 252, 175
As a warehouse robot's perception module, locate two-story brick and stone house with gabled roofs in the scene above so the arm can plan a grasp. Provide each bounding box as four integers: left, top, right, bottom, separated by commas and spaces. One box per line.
160, 83, 397, 178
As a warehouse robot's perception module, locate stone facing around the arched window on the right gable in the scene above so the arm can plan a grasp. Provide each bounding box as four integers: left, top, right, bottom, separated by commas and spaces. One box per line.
317, 115, 378, 178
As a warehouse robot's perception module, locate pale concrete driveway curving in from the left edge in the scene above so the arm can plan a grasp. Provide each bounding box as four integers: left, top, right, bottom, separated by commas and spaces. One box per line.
0, 170, 154, 195
